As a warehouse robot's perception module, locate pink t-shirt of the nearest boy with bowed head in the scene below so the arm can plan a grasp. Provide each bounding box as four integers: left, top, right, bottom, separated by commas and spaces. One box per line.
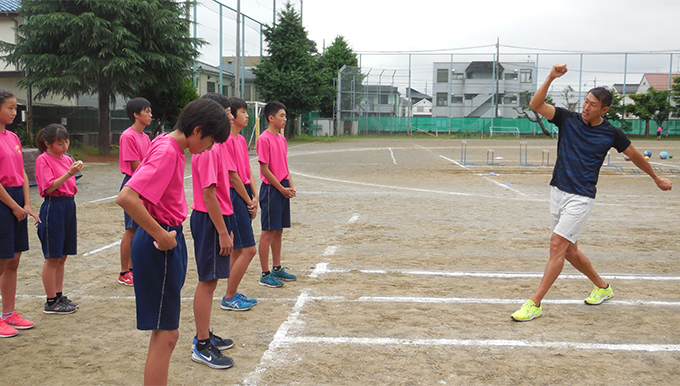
125, 135, 188, 226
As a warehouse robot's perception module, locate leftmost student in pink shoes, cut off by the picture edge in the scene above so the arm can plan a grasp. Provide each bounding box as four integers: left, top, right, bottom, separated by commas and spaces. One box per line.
0, 89, 40, 338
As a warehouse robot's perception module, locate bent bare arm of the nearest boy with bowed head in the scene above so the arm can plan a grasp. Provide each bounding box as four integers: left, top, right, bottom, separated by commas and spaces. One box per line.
116, 186, 177, 251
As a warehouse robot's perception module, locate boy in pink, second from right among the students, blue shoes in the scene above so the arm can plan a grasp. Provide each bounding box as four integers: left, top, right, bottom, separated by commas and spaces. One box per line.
220, 98, 258, 311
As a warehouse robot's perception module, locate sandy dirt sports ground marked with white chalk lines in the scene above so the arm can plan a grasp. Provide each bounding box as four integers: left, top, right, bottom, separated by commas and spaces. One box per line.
0, 138, 680, 386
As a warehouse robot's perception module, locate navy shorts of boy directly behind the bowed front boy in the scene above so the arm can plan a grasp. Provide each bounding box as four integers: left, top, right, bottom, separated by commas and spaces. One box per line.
190, 210, 234, 281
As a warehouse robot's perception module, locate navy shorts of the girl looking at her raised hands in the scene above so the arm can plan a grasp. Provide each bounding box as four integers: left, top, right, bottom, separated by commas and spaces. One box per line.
38, 196, 78, 259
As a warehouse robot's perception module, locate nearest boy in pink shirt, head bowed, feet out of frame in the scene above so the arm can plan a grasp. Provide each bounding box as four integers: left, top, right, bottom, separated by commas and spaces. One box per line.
116, 99, 229, 385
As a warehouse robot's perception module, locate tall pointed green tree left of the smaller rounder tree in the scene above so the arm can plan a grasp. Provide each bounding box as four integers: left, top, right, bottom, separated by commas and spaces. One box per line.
253, 2, 321, 138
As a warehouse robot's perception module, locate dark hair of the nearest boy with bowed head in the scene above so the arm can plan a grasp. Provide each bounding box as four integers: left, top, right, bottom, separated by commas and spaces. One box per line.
175, 98, 231, 143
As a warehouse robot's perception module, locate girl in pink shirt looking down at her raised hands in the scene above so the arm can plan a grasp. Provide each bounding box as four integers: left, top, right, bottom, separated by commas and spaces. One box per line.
35, 123, 83, 314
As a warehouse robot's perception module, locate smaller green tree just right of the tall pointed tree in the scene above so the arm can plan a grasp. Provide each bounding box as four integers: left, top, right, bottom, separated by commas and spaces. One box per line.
319, 36, 364, 118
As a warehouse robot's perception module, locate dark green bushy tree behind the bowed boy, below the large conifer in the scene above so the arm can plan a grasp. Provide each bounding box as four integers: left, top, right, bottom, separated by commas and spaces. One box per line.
135, 77, 198, 138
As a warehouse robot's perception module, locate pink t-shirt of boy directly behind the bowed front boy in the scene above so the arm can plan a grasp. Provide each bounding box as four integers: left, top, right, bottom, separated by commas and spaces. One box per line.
191, 143, 236, 216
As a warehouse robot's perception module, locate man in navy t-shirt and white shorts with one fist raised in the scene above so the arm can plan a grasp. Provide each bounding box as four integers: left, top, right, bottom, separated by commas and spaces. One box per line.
512, 64, 671, 322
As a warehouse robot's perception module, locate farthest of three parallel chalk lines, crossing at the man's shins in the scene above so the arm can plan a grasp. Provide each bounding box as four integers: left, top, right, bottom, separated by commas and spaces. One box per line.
309, 263, 680, 281
